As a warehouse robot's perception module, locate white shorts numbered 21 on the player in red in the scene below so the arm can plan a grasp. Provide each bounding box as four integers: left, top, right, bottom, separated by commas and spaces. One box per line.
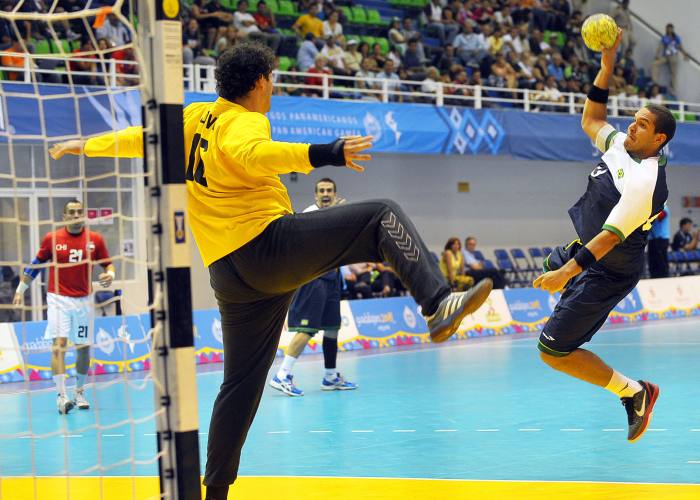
46, 293, 95, 344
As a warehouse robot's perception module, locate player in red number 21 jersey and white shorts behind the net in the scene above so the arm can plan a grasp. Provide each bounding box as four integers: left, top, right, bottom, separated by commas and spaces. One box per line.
12, 200, 115, 414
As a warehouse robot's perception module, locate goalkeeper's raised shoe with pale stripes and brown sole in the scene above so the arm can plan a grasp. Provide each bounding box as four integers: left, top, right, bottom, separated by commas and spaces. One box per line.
425, 278, 493, 342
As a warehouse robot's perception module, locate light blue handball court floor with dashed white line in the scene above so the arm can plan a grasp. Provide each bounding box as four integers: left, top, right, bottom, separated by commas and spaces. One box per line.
0, 320, 700, 483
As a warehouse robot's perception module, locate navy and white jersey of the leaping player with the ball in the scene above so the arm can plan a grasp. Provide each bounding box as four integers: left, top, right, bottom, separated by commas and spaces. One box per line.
569, 131, 668, 275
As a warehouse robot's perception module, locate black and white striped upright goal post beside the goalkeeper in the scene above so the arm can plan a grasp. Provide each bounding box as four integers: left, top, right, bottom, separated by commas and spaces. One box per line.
139, 0, 201, 500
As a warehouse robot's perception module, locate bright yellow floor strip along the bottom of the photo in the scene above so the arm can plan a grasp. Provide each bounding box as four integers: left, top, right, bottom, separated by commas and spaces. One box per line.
0, 477, 700, 500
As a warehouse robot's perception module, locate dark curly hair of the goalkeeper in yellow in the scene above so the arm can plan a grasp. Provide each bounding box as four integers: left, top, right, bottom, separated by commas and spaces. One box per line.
214, 42, 275, 101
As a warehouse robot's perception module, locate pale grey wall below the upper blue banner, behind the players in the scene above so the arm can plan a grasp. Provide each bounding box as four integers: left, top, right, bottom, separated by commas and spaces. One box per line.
186, 154, 700, 308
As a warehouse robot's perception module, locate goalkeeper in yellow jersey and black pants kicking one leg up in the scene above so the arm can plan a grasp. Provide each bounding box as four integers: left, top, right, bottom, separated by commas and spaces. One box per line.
50, 44, 492, 499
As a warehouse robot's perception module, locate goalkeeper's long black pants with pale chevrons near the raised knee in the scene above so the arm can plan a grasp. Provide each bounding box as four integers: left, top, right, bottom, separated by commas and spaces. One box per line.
204, 200, 450, 486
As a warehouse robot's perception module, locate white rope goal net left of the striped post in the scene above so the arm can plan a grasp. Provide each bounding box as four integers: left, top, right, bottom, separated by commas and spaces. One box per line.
0, 0, 198, 499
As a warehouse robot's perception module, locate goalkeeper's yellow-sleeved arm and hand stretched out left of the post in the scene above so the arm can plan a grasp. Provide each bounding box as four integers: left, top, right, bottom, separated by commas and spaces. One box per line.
49, 126, 143, 160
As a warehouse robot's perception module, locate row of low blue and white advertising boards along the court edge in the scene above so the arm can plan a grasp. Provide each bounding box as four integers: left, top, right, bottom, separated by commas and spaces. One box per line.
0, 276, 700, 383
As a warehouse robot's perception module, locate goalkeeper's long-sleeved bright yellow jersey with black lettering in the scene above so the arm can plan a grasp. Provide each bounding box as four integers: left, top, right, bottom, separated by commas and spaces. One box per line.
83, 97, 313, 266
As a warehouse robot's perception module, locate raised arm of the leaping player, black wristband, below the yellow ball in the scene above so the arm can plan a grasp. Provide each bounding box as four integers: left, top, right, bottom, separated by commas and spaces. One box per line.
581, 30, 622, 152
